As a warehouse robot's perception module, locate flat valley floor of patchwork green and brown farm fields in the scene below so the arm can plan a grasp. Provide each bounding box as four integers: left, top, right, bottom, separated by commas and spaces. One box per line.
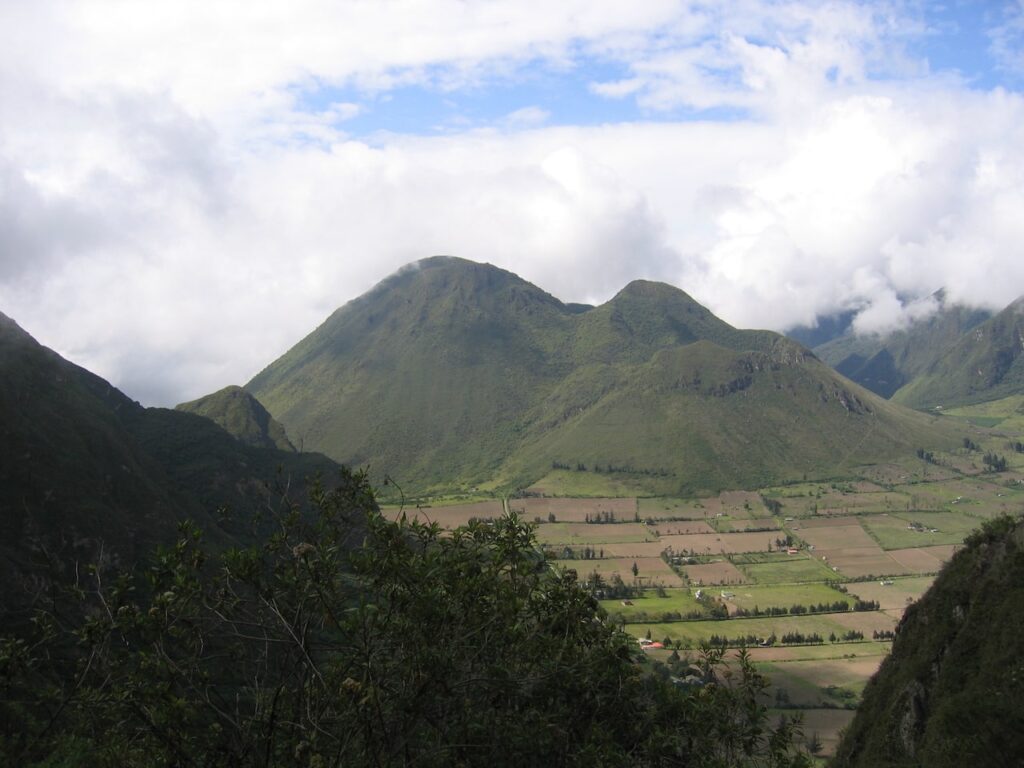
386, 415, 1024, 755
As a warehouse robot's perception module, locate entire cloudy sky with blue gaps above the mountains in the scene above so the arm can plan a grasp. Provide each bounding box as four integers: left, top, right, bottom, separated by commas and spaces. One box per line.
0, 0, 1024, 404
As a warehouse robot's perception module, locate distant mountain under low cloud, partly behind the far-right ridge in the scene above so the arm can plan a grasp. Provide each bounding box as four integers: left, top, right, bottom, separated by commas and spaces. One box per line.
814, 291, 991, 397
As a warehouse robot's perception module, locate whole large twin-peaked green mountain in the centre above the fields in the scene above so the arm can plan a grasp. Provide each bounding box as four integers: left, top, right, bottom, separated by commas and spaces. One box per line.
246, 257, 952, 494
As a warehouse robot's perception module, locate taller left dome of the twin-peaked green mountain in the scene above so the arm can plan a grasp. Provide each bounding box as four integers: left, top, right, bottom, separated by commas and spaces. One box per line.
246, 258, 574, 482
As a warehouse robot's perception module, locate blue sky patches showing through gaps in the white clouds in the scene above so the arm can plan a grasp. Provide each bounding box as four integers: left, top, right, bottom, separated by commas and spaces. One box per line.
297, 0, 1024, 140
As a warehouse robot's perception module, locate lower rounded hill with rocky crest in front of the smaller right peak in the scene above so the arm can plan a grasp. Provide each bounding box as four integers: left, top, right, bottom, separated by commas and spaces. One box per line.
495, 339, 942, 495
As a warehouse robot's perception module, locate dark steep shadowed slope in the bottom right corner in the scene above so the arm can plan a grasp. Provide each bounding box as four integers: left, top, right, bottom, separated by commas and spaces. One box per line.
834, 518, 1024, 768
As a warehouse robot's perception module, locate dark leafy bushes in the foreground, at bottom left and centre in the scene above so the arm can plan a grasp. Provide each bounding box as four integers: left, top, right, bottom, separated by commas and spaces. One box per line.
0, 466, 807, 766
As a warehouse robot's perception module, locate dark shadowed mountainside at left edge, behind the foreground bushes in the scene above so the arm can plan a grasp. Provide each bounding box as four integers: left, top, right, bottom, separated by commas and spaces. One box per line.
0, 314, 337, 608
